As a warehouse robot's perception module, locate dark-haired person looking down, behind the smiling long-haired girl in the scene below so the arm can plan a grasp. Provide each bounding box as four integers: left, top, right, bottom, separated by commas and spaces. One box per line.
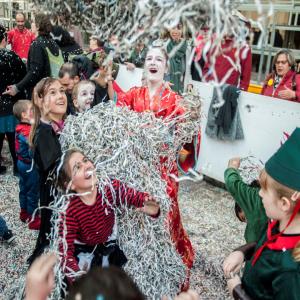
58, 63, 80, 115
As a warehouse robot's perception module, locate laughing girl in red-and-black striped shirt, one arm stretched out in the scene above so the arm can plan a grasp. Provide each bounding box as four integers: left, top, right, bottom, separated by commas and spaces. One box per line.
58, 149, 159, 280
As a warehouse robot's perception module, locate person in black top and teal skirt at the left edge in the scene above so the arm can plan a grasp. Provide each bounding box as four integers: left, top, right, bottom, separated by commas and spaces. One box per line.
0, 25, 26, 174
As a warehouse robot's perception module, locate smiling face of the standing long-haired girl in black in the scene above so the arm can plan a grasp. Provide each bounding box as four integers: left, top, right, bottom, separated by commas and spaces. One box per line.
42, 80, 67, 116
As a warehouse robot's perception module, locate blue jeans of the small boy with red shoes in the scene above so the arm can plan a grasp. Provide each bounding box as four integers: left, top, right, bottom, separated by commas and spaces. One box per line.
17, 160, 40, 215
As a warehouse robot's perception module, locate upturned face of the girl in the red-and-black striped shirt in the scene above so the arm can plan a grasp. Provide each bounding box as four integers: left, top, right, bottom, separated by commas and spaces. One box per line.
67, 152, 96, 193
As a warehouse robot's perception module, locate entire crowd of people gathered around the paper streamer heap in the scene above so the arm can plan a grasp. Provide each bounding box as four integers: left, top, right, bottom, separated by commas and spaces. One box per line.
0, 8, 300, 300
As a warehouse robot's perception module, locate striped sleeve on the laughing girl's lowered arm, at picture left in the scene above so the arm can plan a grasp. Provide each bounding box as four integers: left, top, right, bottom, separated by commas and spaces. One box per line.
59, 209, 80, 276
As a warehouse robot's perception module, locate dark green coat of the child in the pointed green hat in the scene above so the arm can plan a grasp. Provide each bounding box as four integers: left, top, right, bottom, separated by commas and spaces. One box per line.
242, 234, 300, 300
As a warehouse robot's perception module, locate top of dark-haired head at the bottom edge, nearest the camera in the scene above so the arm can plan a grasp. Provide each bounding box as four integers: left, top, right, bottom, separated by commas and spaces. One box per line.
67, 266, 146, 300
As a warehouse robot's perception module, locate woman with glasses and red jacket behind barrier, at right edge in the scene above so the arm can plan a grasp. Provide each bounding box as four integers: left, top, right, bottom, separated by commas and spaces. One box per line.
261, 49, 300, 102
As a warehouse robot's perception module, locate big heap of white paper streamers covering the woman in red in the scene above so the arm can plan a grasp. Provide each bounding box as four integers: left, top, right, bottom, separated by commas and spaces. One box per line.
50, 95, 200, 299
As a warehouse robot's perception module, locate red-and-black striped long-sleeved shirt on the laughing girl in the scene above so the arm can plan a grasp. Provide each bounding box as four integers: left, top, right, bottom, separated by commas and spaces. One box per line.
59, 180, 146, 273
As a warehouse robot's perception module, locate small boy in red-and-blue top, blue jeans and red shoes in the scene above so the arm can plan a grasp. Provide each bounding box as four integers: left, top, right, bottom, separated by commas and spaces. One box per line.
13, 100, 41, 230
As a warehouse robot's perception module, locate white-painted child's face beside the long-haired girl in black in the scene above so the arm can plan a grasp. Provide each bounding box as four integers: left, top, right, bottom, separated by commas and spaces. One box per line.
72, 80, 95, 113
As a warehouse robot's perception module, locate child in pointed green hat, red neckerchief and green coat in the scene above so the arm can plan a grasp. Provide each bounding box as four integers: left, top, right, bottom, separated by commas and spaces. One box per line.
223, 128, 300, 300
